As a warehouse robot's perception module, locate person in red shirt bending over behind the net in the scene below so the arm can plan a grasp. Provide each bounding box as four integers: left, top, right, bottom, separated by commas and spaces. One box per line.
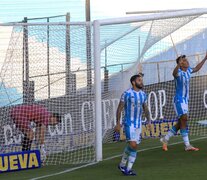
10, 104, 61, 163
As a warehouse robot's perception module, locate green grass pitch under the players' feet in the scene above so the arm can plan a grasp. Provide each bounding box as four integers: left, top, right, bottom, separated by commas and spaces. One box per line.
0, 137, 207, 180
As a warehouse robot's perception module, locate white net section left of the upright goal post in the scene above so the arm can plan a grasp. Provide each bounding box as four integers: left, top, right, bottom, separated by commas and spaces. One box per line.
0, 25, 95, 164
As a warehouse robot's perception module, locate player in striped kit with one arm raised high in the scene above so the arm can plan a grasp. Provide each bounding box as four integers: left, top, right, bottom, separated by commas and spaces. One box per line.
160, 53, 207, 151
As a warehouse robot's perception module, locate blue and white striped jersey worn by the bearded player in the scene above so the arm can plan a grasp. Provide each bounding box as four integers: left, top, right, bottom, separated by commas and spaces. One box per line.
121, 88, 147, 128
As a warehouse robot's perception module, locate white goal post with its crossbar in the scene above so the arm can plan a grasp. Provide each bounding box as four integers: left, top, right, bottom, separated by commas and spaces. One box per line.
93, 8, 207, 161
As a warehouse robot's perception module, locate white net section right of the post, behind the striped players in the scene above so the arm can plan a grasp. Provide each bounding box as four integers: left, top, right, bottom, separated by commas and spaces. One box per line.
94, 11, 207, 146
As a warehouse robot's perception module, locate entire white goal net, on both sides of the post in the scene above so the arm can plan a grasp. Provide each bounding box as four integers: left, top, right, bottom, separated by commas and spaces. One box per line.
0, 10, 207, 165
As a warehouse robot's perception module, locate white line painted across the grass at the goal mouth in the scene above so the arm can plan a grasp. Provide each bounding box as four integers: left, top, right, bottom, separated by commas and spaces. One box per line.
30, 137, 207, 180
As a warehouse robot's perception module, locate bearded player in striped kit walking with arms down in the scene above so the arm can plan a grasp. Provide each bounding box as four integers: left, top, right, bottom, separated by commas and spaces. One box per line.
115, 73, 151, 176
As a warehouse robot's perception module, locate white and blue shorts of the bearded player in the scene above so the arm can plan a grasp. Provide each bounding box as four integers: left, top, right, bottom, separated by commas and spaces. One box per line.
124, 125, 142, 144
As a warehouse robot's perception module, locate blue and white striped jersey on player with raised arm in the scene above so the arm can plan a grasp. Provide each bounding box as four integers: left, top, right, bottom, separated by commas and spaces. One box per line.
175, 67, 193, 103
